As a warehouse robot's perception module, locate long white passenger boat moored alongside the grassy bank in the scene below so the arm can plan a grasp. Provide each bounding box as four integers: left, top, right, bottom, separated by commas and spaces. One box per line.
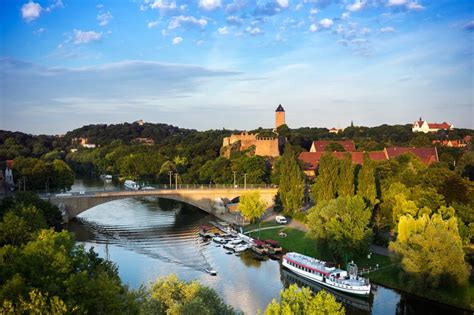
282, 252, 370, 297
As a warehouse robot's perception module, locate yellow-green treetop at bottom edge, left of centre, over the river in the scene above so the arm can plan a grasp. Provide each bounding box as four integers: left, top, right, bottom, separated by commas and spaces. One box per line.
141, 274, 235, 315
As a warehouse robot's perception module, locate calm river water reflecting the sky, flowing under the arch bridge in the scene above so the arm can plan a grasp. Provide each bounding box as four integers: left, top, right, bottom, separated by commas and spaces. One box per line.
68, 180, 462, 315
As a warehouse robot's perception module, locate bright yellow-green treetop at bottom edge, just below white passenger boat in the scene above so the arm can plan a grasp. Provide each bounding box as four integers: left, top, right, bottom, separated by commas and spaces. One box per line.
265, 284, 345, 315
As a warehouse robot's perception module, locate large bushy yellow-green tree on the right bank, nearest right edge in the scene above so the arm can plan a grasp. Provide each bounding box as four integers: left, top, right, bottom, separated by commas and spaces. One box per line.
389, 214, 469, 288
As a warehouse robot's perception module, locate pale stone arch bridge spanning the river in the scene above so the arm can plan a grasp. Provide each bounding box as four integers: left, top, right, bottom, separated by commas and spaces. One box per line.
47, 188, 278, 222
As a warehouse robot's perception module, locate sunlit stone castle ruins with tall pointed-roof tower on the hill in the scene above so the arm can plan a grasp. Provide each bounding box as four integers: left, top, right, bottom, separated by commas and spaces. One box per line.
221, 104, 285, 157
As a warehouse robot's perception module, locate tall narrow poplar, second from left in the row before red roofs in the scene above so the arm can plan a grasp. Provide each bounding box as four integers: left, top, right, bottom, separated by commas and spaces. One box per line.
311, 153, 339, 202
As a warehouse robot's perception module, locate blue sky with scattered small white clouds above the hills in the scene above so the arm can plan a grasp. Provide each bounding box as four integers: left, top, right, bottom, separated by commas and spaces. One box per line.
0, 0, 474, 134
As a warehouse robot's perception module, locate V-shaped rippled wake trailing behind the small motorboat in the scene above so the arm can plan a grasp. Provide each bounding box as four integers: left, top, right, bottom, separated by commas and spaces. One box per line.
76, 218, 215, 272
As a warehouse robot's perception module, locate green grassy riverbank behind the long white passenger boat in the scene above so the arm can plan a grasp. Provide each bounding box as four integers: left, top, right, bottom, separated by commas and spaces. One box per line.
247, 228, 474, 309
